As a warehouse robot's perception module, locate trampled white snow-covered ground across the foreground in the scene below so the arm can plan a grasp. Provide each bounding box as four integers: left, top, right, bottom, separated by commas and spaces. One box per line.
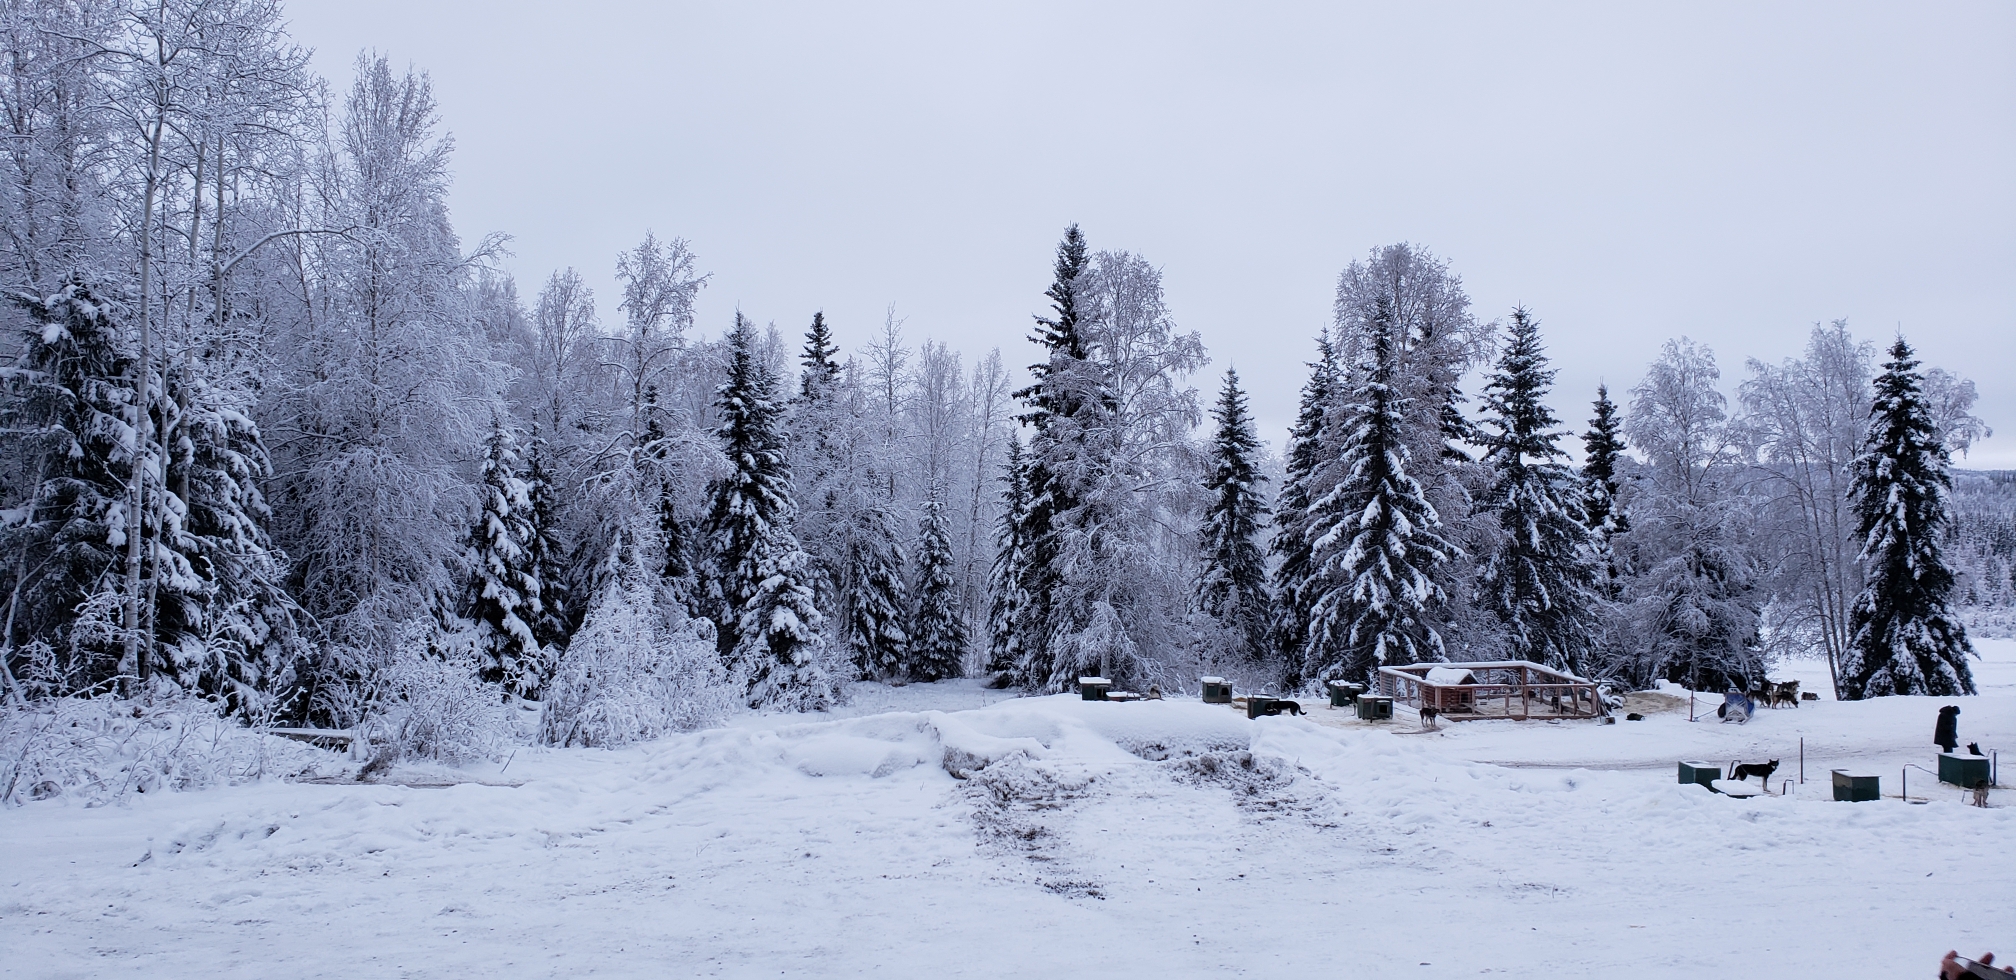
0, 641, 2016, 978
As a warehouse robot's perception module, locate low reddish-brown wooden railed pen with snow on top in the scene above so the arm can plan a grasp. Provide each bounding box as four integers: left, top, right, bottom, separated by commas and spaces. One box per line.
1377, 659, 1603, 722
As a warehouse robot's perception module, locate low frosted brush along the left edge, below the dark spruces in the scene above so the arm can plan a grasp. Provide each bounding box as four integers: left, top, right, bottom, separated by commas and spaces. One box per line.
0, 696, 341, 807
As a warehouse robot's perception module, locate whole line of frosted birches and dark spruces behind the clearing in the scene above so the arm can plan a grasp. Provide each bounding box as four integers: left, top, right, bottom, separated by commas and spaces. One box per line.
0, 0, 1983, 744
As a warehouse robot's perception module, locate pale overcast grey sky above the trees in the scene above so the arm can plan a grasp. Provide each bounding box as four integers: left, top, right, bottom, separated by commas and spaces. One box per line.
288, 0, 2016, 468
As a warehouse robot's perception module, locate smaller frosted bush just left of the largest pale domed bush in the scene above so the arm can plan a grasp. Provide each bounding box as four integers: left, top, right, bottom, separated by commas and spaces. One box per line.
365, 625, 512, 762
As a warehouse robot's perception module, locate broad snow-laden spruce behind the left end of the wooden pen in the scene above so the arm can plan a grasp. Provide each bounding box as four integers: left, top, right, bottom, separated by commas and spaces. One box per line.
1300, 300, 1460, 682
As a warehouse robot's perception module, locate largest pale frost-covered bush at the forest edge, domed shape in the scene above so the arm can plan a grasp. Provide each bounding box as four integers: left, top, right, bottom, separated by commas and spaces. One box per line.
538, 575, 742, 746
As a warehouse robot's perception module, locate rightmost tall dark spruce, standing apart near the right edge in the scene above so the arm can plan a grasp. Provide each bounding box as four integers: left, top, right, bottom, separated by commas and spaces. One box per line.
1841, 337, 1974, 700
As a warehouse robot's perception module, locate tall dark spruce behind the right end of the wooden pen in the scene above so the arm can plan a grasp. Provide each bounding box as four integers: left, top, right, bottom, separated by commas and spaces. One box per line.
1478, 307, 1597, 673
